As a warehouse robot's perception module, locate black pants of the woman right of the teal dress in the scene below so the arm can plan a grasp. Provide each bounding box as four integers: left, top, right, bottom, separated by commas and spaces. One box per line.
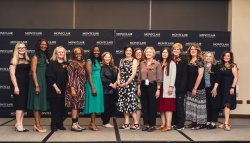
101, 94, 115, 125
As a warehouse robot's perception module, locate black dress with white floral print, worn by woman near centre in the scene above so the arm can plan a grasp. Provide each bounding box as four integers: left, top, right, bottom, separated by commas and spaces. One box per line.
117, 59, 137, 113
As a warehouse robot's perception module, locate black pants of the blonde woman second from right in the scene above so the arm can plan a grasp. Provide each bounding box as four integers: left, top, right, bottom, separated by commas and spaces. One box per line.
206, 87, 219, 122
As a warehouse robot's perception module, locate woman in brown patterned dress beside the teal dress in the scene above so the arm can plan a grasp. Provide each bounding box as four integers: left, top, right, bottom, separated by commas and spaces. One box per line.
65, 47, 86, 132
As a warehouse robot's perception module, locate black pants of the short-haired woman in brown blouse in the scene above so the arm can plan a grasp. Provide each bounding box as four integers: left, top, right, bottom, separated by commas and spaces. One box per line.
141, 82, 157, 126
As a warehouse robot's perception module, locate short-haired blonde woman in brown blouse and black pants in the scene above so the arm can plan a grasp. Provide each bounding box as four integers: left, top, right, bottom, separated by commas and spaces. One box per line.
138, 47, 162, 132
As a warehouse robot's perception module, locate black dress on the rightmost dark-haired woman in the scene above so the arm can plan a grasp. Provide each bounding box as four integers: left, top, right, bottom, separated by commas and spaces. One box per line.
220, 64, 236, 110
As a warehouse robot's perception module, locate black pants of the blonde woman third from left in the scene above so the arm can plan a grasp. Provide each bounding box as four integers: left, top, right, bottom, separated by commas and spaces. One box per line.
49, 97, 65, 125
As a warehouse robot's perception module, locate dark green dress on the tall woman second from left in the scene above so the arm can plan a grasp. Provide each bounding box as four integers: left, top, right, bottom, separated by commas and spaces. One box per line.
27, 54, 49, 111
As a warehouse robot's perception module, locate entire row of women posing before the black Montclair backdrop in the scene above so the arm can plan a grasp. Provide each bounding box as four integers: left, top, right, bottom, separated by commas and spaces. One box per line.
10, 39, 238, 132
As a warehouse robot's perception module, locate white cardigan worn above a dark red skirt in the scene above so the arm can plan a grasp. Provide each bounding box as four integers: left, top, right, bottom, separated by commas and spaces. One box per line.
163, 61, 176, 98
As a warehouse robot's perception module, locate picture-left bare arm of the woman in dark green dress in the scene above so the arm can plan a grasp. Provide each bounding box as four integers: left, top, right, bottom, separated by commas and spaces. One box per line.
31, 56, 40, 94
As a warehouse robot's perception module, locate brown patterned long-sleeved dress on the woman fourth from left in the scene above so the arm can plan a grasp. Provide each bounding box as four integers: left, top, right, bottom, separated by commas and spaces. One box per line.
65, 61, 86, 109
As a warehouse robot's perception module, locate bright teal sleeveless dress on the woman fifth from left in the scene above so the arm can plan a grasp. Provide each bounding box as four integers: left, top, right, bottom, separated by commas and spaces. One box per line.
84, 59, 104, 114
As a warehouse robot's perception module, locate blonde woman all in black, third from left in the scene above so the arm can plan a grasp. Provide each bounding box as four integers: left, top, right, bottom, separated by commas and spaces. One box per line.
46, 46, 68, 131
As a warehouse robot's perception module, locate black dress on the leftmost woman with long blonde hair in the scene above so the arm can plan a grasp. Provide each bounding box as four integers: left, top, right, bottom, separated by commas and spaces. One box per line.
11, 64, 30, 110
